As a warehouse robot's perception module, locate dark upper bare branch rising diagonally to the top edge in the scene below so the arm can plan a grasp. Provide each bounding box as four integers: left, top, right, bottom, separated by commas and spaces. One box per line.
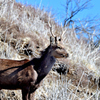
64, 0, 91, 26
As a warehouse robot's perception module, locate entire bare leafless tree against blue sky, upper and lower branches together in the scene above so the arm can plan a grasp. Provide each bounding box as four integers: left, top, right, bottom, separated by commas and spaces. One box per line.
64, 0, 100, 50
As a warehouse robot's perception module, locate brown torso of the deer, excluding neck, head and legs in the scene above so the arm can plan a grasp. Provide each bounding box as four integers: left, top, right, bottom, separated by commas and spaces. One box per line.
0, 59, 37, 89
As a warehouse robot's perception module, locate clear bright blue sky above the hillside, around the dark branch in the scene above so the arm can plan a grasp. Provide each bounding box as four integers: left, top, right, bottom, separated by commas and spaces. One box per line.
16, 0, 100, 22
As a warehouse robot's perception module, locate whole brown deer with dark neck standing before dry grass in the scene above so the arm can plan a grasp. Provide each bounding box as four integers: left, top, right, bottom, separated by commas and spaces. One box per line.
0, 37, 69, 100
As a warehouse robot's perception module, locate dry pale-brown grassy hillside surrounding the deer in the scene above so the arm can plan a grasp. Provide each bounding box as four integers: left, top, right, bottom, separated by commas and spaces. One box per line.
0, 0, 100, 100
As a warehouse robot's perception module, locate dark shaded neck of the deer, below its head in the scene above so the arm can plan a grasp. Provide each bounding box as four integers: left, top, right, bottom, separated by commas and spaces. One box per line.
34, 49, 56, 82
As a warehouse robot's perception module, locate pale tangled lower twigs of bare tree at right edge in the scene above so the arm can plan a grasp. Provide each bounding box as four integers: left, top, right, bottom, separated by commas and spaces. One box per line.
75, 17, 100, 50
